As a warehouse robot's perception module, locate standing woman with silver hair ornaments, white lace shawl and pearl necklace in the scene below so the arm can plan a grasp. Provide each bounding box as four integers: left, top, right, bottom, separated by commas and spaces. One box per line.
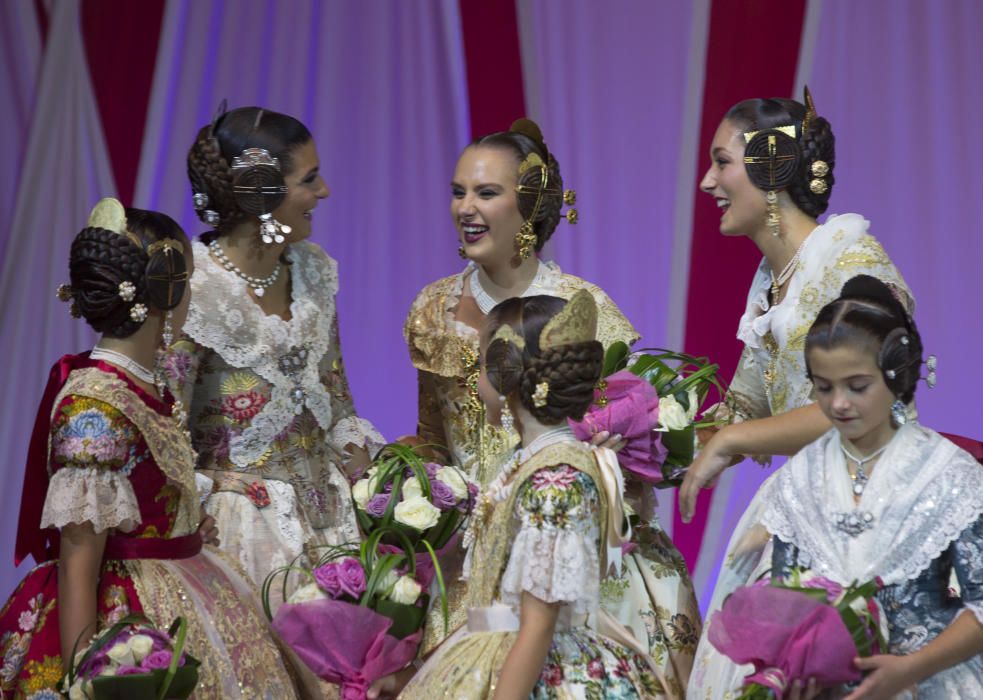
168, 107, 383, 594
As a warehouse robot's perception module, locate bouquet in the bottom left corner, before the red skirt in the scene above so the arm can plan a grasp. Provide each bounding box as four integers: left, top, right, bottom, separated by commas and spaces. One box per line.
63, 615, 200, 700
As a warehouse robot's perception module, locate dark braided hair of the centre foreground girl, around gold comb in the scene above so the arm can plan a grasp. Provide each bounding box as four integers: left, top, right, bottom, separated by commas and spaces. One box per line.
485, 295, 604, 425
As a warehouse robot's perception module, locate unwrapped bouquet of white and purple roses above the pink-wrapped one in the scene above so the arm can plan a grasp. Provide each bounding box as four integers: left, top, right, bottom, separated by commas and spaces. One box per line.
352, 443, 478, 585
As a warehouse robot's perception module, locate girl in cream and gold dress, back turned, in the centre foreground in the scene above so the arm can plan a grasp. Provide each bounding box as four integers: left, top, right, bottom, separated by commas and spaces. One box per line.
400, 290, 664, 700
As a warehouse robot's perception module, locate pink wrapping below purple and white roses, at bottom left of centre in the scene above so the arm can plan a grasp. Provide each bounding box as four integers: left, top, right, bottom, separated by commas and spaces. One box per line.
273, 600, 421, 700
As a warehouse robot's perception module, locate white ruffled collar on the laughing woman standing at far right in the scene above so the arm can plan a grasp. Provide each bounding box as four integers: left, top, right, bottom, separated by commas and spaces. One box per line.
737, 214, 870, 348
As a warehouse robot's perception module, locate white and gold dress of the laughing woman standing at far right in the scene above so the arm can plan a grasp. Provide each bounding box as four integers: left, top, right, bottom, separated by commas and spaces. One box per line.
687, 214, 914, 698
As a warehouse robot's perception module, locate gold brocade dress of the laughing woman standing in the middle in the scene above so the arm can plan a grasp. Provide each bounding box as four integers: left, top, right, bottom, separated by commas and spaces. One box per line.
403, 262, 700, 695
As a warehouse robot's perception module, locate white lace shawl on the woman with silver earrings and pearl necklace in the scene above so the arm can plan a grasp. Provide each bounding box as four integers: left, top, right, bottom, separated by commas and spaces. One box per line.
184, 241, 344, 467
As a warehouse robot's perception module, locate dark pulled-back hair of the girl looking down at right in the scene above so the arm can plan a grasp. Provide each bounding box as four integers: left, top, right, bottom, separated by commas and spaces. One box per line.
805, 275, 923, 403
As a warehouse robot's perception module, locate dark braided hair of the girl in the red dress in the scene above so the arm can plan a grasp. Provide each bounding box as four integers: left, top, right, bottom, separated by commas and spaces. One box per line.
68, 209, 189, 338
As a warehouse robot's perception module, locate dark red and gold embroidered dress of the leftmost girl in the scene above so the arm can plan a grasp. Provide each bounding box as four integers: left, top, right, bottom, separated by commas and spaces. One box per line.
0, 355, 295, 700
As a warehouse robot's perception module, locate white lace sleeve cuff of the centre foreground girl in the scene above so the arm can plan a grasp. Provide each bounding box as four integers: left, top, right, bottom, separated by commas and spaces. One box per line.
499, 525, 601, 615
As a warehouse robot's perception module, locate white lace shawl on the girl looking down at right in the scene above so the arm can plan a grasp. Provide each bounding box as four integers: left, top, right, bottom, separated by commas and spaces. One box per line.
762, 423, 983, 585
